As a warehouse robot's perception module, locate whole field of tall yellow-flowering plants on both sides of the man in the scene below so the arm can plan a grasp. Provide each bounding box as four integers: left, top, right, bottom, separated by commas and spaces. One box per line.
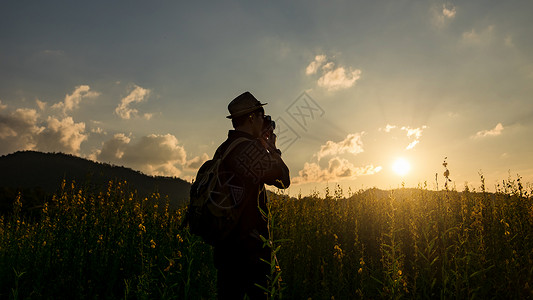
0, 178, 533, 299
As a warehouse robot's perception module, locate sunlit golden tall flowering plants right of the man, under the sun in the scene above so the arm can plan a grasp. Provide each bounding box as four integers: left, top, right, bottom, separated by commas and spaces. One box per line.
275, 180, 533, 299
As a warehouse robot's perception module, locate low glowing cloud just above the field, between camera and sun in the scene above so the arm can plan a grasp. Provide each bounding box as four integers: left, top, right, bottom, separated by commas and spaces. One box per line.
291, 157, 382, 184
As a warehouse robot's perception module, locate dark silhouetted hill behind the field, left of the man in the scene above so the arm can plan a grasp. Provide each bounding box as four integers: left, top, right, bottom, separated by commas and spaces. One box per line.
0, 151, 190, 212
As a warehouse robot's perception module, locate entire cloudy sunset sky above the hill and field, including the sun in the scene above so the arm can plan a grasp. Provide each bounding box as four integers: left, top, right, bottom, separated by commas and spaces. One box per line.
0, 0, 533, 195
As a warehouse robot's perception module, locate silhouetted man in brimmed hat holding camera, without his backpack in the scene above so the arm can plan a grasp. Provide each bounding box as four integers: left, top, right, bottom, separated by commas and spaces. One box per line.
214, 92, 290, 299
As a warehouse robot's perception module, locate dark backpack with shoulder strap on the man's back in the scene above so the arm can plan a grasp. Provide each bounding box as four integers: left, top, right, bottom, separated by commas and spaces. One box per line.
186, 137, 250, 245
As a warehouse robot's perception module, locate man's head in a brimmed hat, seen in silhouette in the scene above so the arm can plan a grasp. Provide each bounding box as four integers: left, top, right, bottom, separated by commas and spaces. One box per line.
227, 92, 266, 137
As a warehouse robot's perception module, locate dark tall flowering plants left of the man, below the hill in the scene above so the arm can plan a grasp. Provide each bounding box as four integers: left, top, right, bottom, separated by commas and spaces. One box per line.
0, 182, 215, 299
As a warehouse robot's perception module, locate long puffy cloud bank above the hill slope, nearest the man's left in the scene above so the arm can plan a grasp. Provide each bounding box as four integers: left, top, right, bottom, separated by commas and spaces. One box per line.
92, 133, 187, 176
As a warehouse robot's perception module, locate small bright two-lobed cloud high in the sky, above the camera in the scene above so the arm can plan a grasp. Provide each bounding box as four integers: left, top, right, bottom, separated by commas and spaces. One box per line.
305, 55, 361, 91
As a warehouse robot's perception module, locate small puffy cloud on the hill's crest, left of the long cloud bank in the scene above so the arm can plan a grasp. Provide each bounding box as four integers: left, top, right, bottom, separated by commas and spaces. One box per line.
36, 117, 87, 154
